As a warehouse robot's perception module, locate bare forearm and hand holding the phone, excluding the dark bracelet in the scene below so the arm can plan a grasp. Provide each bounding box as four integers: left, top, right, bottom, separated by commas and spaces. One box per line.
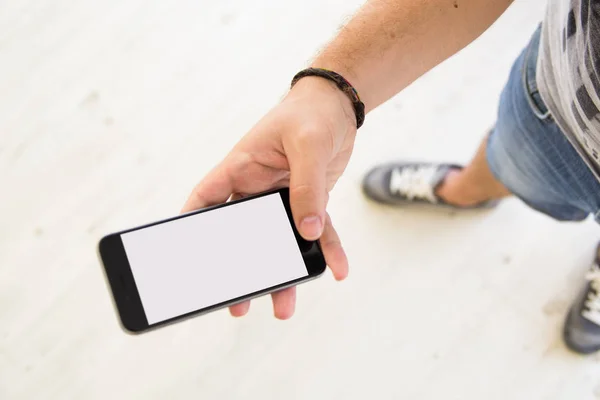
183, 0, 512, 319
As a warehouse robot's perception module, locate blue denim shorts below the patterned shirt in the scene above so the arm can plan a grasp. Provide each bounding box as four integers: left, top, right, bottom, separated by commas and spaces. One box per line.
486, 25, 600, 222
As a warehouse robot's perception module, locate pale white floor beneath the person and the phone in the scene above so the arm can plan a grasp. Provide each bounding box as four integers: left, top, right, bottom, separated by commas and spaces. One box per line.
0, 0, 600, 400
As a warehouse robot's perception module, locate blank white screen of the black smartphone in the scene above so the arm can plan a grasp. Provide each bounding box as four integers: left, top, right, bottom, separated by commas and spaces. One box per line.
121, 193, 308, 324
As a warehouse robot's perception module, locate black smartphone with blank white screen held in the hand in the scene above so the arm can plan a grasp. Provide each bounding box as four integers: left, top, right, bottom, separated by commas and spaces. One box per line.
98, 189, 326, 333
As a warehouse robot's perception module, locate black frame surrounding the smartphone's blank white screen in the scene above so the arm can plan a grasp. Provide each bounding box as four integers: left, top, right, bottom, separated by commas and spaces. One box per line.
98, 188, 326, 333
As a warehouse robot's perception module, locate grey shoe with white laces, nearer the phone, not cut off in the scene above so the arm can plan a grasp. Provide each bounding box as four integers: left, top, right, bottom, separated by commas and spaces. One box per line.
362, 163, 498, 209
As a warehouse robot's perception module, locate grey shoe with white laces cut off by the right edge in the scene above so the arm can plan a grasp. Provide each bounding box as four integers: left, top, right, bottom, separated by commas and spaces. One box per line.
564, 245, 600, 354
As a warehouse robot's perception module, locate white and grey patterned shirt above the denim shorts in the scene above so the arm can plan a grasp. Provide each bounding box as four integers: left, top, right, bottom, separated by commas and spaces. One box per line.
537, 0, 600, 180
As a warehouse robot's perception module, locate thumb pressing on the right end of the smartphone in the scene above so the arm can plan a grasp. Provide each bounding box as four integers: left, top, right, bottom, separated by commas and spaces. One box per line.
288, 146, 327, 240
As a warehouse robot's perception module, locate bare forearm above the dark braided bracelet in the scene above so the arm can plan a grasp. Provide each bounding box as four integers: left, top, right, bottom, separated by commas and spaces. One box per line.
312, 0, 511, 111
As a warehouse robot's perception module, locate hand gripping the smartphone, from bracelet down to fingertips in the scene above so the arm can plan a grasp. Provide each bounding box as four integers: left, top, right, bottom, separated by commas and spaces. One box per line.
182, 77, 356, 319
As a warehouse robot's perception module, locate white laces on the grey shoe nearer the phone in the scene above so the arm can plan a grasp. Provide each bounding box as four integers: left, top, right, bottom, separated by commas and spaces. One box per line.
390, 166, 438, 203
